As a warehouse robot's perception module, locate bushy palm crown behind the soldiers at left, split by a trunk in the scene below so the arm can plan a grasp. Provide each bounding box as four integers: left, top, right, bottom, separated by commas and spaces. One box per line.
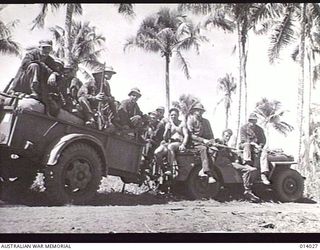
50, 22, 105, 78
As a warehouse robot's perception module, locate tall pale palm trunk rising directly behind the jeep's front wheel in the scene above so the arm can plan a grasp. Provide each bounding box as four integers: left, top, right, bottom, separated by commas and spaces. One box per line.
298, 3, 307, 170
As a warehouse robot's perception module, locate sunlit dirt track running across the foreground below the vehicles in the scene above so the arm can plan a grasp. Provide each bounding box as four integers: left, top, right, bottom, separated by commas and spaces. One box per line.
0, 193, 320, 233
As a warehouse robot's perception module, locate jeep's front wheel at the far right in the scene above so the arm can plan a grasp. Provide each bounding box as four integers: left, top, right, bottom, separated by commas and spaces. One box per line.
272, 169, 304, 202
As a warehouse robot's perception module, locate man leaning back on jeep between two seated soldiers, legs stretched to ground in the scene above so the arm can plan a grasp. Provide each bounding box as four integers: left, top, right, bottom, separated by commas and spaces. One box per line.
215, 129, 260, 202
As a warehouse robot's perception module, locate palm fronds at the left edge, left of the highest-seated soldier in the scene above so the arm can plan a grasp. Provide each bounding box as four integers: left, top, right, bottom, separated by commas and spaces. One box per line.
0, 5, 21, 56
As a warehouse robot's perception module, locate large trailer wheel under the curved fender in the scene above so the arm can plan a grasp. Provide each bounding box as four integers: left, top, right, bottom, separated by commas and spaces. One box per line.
44, 143, 102, 205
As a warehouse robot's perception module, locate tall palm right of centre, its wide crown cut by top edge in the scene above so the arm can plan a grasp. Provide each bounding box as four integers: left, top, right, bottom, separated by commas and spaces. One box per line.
179, 3, 277, 145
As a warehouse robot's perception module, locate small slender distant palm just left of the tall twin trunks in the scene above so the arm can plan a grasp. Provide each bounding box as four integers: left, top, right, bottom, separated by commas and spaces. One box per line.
216, 74, 237, 129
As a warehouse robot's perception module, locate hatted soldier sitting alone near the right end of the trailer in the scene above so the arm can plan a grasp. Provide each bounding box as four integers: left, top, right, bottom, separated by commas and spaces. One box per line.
118, 88, 143, 129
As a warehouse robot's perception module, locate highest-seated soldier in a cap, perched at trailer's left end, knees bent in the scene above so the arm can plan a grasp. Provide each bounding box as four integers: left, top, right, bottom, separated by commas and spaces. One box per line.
10, 40, 58, 101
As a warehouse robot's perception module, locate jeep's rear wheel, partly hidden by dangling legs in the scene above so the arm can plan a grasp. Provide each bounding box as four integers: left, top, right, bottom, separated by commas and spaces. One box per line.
186, 167, 221, 200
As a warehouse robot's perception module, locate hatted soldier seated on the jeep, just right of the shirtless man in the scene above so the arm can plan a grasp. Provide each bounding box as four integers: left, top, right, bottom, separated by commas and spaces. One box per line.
187, 103, 216, 183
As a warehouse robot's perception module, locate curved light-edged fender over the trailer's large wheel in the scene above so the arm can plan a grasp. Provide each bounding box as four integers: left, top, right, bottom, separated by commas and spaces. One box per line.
43, 134, 107, 167
